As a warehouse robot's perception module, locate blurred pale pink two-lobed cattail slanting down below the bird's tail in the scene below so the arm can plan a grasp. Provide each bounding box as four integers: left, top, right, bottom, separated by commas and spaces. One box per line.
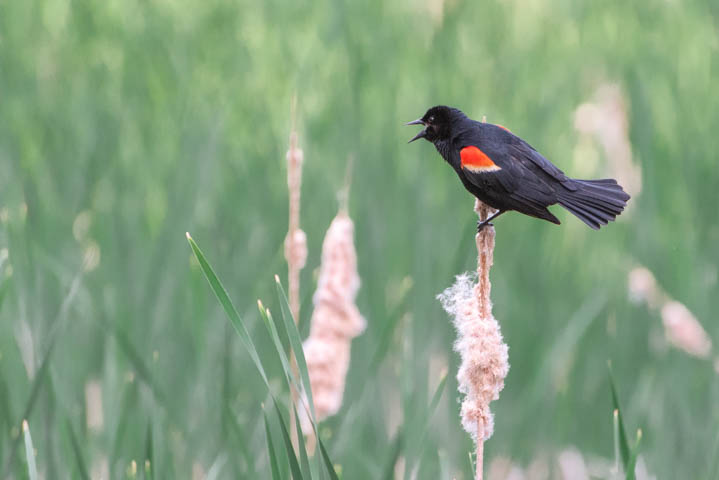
628, 266, 712, 358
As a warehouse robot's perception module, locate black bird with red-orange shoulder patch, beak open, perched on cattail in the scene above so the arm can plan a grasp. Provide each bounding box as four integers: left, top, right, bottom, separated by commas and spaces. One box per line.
407, 105, 629, 231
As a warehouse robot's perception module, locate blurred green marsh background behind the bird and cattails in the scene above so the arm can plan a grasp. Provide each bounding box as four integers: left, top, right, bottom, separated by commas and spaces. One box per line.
0, 0, 719, 479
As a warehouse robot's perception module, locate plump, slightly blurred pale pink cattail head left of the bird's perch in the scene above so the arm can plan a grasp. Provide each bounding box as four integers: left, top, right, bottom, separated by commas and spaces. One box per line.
300, 207, 365, 435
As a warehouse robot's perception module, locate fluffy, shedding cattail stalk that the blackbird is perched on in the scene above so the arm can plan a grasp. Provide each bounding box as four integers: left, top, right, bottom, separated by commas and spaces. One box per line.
438, 201, 509, 479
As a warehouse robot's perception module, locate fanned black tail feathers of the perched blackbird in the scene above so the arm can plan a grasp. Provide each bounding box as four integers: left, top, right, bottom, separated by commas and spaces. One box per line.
558, 178, 630, 230
